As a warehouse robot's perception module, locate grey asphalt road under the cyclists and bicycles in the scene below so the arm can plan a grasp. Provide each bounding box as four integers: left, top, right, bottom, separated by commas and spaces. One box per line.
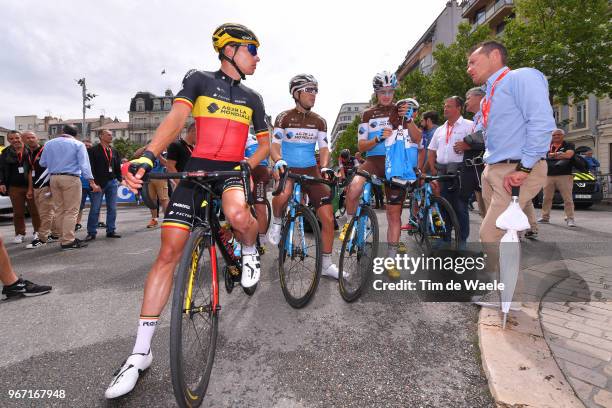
0, 208, 612, 407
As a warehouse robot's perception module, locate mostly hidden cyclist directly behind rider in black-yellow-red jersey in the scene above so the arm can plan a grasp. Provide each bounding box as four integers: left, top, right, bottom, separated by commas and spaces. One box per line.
244, 132, 270, 247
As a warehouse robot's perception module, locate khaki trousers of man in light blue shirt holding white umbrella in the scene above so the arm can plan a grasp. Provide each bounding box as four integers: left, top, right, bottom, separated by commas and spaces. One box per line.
480, 161, 548, 293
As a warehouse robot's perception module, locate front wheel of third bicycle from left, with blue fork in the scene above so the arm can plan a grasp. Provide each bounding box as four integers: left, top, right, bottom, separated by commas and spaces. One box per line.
338, 206, 378, 302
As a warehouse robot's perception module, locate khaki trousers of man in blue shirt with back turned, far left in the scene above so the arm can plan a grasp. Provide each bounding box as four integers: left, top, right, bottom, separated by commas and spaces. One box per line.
50, 175, 82, 245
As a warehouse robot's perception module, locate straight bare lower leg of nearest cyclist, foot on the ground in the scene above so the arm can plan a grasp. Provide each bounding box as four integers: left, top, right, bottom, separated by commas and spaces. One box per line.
140, 228, 189, 316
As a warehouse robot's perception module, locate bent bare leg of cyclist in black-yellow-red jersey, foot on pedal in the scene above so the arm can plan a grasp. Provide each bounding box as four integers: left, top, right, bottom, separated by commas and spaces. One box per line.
221, 189, 258, 246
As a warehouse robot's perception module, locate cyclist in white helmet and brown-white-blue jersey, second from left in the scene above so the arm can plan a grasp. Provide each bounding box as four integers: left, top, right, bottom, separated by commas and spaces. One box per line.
267, 74, 338, 279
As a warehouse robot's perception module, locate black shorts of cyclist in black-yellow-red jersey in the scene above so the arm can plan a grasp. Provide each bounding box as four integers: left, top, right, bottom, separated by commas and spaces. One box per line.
162, 157, 244, 231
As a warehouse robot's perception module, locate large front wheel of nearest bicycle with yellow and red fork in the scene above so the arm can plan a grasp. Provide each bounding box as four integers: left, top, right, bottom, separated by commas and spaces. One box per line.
170, 227, 219, 407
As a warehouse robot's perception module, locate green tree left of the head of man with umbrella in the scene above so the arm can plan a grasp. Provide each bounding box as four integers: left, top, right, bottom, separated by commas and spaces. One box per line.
397, 23, 491, 117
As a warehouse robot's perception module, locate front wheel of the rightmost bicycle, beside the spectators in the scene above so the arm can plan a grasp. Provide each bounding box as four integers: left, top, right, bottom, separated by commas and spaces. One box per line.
422, 196, 459, 255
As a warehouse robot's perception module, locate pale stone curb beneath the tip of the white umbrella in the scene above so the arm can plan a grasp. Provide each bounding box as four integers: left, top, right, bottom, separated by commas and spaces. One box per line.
478, 303, 584, 408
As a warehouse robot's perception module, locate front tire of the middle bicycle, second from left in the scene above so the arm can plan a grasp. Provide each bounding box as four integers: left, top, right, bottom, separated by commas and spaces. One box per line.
278, 205, 323, 309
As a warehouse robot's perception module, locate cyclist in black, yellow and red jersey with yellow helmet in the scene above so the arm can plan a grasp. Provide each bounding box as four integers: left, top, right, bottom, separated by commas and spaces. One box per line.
105, 24, 270, 399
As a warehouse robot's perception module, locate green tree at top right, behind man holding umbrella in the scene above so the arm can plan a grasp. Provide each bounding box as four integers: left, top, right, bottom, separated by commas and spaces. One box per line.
503, 0, 612, 103
